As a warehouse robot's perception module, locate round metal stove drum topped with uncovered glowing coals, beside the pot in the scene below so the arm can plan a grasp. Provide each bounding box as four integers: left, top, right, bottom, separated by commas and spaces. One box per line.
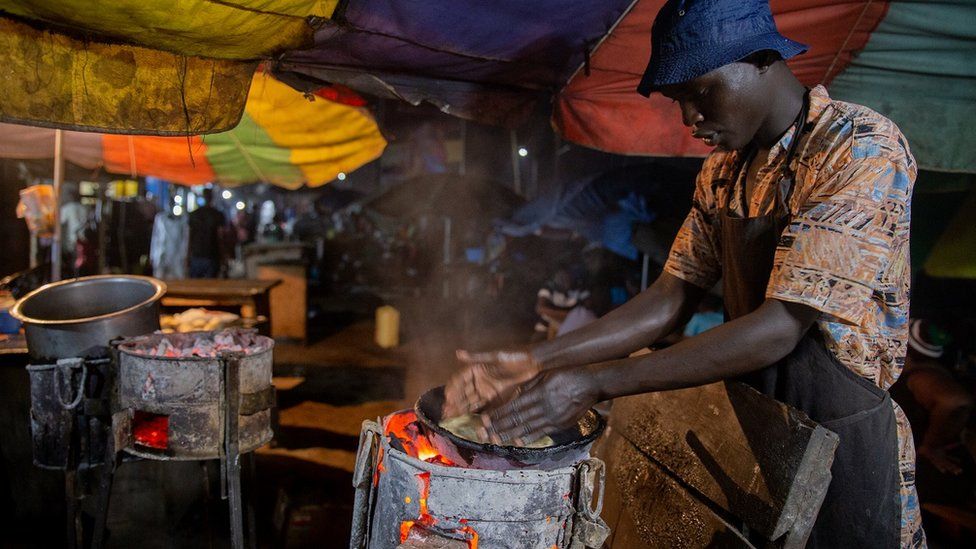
113, 329, 274, 460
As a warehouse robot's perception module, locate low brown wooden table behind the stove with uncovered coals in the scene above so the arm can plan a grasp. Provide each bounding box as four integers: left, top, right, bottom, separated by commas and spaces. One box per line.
161, 278, 281, 333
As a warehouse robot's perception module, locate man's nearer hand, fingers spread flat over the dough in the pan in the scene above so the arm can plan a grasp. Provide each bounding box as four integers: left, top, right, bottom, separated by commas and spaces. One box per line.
482, 368, 597, 445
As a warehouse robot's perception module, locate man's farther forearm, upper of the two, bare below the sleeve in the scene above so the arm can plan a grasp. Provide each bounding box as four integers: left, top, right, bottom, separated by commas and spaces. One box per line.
531, 273, 704, 368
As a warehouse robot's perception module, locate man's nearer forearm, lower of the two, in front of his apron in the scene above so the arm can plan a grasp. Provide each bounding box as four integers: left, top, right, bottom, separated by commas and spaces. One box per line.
581, 300, 816, 401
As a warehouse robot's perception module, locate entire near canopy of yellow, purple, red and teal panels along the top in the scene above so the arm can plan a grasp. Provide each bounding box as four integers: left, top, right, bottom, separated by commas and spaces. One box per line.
0, 0, 976, 173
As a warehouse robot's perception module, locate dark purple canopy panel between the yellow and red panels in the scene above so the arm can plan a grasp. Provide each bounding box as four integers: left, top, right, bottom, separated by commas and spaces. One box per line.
277, 0, 634, 122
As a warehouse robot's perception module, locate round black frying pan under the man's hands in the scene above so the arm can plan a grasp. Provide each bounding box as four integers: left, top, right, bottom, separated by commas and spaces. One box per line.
414, 386, 607, 471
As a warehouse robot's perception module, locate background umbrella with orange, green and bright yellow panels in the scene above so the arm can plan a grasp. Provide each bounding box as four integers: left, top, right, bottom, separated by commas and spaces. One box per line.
0, 73, 386, 189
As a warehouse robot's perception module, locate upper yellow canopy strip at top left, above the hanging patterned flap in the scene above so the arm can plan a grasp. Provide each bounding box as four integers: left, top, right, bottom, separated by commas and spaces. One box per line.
0, 0, 318, 59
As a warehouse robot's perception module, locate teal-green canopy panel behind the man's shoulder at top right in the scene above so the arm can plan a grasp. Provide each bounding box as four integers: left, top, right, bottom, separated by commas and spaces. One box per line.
830, 0, 976, 173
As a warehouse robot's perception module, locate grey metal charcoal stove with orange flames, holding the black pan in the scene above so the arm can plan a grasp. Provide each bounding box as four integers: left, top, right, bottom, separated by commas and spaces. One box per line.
349, 388, 609, 549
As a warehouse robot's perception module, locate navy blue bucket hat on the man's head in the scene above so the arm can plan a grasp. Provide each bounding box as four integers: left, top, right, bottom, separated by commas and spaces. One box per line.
637, 0, 807, 97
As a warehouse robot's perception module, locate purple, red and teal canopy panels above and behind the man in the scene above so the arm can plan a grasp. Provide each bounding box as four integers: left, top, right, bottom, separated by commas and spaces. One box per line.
275, 0, 976, 172
